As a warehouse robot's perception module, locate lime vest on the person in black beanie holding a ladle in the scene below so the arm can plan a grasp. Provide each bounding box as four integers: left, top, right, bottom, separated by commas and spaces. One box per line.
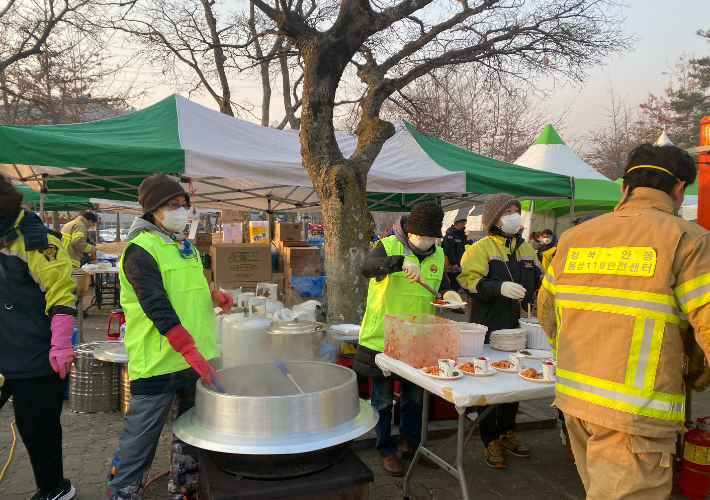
359, 236, 444, 352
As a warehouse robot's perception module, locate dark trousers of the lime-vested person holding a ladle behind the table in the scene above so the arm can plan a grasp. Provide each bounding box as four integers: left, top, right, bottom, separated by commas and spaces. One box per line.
371, 378, 424, 455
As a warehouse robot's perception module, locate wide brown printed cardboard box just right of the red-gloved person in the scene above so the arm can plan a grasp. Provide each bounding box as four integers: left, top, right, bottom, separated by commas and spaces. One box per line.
210, 243, 271, 284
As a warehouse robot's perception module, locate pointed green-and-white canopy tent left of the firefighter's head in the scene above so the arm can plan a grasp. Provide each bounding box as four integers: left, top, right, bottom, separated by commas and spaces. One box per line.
515, 124, 621, 232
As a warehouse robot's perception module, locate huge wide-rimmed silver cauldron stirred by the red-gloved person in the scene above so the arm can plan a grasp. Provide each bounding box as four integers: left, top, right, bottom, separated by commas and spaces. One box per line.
173, 361, 378, 477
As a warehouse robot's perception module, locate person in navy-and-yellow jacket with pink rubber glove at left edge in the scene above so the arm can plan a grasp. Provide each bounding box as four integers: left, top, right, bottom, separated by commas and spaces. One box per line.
0, 174, 76, 500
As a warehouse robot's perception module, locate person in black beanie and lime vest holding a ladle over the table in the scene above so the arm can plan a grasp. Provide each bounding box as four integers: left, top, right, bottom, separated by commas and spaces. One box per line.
353, 202, 461, 476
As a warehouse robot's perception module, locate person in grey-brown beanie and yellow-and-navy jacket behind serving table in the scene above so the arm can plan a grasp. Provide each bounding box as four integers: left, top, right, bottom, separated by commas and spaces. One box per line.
458, 193, 543, 468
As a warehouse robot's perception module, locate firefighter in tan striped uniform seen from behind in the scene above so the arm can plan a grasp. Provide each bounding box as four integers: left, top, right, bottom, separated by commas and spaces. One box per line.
539, 144, 710, 500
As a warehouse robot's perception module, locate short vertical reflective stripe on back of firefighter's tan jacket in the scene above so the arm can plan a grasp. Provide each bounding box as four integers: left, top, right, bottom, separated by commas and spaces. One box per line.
624, 317, 665, 391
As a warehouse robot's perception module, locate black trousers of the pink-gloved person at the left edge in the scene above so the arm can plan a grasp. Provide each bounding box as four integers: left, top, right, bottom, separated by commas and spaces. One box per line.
0, 373, 66, 495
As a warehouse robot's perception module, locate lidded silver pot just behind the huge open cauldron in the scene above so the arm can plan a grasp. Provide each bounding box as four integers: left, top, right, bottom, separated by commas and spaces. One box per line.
266, 318, 325, 361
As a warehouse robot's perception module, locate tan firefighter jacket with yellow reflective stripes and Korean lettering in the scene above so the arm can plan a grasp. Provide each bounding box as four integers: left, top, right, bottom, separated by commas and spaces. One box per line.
539, 188, 710, 437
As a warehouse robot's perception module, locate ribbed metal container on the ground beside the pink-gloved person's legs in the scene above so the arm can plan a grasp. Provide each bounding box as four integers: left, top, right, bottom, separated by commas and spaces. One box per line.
67, 341, 121, 413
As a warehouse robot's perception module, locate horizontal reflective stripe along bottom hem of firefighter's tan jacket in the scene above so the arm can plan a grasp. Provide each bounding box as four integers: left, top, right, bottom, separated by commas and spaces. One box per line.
555, 369, 685, 422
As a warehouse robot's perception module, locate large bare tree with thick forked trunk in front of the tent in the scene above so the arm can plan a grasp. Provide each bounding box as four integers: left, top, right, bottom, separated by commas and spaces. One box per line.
252, 0, 626, 322
